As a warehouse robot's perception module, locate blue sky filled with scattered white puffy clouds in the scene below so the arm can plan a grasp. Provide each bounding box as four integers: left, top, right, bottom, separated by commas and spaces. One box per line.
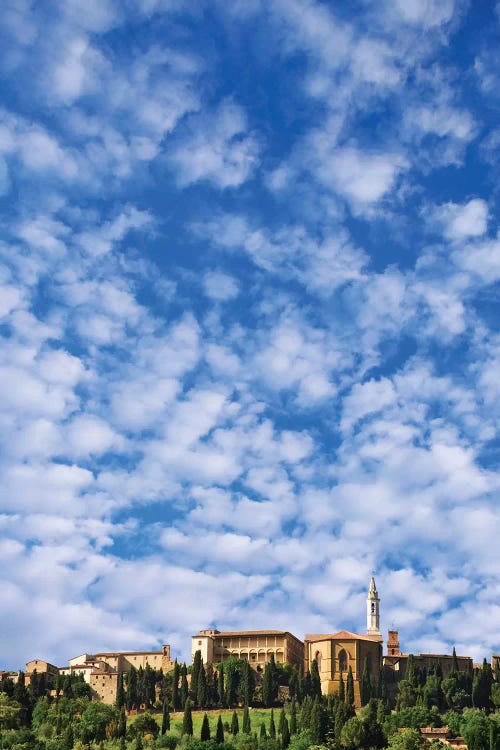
0, 0, 500, 668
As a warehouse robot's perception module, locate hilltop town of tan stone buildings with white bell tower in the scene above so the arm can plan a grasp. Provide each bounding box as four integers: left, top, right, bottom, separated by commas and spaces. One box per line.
0, 577, 500, 708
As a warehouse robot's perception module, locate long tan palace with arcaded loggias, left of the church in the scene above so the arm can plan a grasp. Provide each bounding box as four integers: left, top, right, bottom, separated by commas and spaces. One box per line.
191, 630, 304, 672
